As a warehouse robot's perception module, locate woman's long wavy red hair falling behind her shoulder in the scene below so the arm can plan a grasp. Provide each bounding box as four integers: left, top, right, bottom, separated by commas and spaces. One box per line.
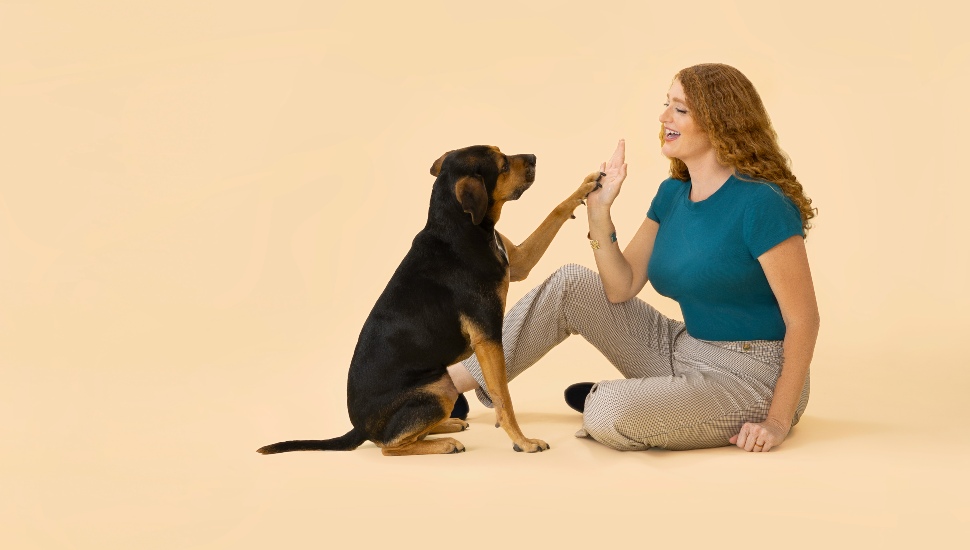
660, 63, 818, 235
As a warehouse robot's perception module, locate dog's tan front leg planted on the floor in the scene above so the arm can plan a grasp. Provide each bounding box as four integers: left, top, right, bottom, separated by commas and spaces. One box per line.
461, 315, 549, 453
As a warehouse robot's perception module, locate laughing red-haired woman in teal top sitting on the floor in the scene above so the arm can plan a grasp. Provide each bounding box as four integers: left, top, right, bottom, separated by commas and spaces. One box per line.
449, 64, 819, 452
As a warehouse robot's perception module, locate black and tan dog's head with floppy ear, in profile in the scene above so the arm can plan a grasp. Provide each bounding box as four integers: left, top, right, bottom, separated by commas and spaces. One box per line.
431, 145, 536, 225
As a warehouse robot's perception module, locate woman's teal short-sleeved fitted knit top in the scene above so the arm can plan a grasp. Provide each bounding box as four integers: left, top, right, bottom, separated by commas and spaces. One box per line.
647, 176, 803, 341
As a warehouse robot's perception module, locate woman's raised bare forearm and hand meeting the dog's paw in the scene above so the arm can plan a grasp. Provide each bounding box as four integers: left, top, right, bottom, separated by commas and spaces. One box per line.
586, 139, 660, 304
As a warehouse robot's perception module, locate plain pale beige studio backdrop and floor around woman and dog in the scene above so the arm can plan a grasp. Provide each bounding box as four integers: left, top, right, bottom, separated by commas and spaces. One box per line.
0, 0, 970, 549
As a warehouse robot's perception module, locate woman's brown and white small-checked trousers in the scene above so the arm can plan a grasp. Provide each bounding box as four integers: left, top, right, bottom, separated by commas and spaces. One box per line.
463, 264, 809, 450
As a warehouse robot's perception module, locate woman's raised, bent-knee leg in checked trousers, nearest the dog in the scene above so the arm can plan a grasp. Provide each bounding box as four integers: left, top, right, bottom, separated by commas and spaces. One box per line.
460, 264, 684, 407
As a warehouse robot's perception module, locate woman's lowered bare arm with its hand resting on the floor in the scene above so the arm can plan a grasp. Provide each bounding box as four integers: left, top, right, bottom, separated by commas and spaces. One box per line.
730, 235, 819, 451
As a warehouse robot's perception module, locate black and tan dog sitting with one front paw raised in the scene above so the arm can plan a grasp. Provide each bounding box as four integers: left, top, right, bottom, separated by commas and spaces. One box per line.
259, 145, 599, 455
